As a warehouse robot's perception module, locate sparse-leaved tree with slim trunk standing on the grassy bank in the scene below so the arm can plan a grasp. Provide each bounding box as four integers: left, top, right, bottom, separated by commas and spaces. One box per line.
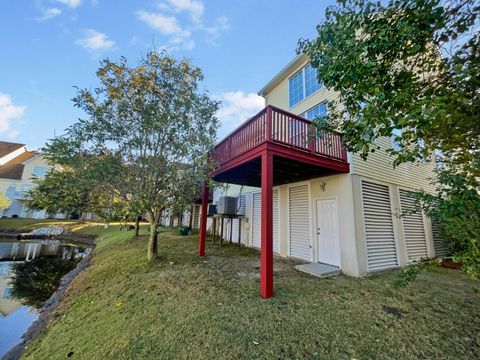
46, 51, 219, 260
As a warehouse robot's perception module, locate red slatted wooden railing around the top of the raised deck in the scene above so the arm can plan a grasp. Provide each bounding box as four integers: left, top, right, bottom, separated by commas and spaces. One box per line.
213, 105, 347, 165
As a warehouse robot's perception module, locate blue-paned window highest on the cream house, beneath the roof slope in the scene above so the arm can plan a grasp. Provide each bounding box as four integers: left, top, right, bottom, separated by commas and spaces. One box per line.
288, 64, 322, 107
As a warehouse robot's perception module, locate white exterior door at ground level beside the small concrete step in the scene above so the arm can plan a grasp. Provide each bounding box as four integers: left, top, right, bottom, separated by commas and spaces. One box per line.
316, 199, 340, 266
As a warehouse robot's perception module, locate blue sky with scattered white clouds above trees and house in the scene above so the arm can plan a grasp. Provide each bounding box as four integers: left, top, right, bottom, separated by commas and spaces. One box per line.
0, 0, 333, 149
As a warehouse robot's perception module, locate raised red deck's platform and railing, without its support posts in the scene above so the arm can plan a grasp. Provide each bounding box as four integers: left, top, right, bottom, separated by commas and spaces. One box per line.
212, 106, 349, 186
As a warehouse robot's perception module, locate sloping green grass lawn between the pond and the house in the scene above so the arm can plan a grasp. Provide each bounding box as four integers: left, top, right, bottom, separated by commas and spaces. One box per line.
4, 223, 480, 359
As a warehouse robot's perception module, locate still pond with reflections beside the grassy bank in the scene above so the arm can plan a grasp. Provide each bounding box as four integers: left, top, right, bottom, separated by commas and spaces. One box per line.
0, 238, 90, 357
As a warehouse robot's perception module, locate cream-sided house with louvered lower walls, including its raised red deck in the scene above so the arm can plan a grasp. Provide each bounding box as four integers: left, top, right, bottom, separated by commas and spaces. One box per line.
199, 55, 443, 297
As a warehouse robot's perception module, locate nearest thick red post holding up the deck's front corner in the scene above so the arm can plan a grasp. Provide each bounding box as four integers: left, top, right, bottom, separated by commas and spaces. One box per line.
260, 150, 273, 299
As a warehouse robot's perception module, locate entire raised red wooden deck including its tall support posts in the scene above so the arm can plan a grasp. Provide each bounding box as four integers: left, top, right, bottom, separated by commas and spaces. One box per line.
198, 106, 349, 298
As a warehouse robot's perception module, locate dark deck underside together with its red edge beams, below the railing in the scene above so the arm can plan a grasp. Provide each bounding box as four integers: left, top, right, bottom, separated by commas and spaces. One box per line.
213, 144, 349, 187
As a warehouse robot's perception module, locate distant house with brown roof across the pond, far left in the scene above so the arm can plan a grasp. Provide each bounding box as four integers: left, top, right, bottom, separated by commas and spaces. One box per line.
0, 141, 50, 219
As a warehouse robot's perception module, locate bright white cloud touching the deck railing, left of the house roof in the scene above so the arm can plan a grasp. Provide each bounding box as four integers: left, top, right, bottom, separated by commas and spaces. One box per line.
216, 91, 265, 136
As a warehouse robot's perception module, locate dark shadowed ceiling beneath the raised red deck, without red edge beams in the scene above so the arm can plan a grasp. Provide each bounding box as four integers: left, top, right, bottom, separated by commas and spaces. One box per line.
213, 156, 339, 187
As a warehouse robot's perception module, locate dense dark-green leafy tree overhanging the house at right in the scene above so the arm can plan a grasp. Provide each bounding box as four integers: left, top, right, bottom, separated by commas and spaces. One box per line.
298, 0, 480, 277
